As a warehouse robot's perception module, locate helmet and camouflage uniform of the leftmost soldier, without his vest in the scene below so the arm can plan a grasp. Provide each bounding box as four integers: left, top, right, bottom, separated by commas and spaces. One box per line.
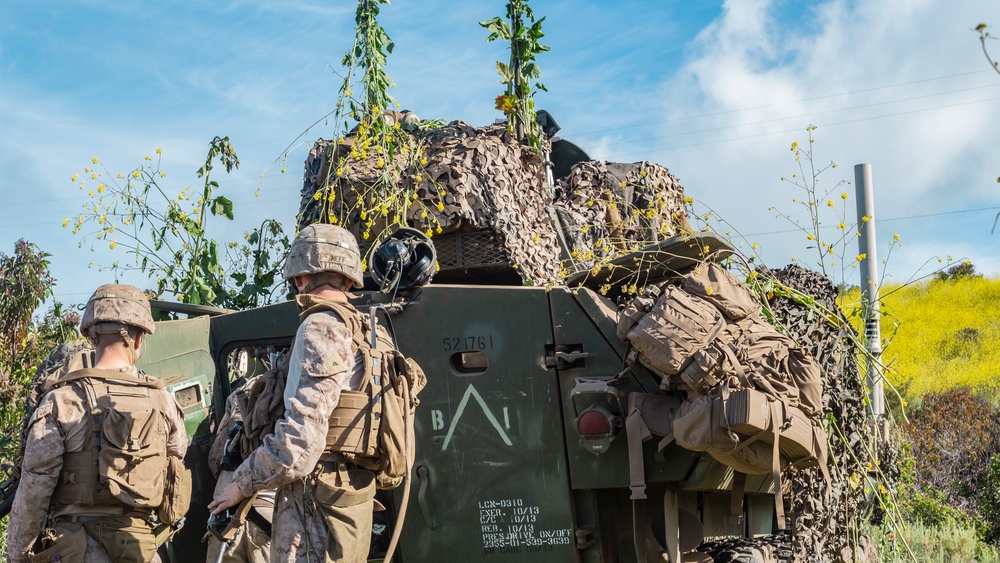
7, 284, 188, 563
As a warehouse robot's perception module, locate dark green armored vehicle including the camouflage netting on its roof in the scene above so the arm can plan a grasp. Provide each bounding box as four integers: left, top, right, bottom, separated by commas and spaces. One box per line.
0, 114, 868, 563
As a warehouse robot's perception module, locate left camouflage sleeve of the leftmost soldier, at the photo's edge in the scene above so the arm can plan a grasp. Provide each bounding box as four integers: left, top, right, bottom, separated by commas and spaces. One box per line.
7, 393, 65, 563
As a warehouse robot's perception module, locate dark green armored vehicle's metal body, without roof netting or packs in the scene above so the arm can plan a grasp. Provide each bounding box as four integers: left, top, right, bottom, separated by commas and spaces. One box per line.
125, 230, 792, 562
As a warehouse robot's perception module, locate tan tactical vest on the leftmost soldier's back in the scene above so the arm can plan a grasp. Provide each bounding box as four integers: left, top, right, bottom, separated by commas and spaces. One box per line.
51, 369, 170, 509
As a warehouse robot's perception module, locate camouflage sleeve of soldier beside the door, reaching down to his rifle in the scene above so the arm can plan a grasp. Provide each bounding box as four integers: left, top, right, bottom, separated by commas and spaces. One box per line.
233, 313, 354, 496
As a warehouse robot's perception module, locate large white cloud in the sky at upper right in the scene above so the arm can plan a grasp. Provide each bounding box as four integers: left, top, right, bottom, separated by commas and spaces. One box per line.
659, 0, 1000, 280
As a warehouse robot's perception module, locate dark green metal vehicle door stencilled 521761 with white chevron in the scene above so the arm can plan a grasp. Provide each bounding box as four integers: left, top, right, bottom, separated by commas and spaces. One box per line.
393, 286, 578, 562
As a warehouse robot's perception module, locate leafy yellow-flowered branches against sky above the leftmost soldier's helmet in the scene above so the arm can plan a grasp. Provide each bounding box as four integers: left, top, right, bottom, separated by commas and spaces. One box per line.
63, 137, 287, 308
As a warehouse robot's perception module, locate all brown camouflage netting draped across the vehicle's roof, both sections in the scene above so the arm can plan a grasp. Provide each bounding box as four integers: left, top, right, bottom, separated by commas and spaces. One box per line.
298, 118, 691, 284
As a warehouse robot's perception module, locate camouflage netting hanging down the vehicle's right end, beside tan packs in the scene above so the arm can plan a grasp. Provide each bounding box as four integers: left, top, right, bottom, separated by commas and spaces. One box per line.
770, 265, 880, 563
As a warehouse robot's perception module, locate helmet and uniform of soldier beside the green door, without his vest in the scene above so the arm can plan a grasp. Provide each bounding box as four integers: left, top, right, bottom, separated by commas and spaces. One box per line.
209, 224, 375, 563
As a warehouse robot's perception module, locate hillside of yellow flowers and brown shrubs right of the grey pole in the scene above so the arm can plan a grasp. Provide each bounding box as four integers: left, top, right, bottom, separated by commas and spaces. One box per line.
841, 274, 1000, 561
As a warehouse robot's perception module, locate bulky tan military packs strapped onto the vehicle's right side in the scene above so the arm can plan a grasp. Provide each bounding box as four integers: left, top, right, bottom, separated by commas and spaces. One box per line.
616, 263, 829, 527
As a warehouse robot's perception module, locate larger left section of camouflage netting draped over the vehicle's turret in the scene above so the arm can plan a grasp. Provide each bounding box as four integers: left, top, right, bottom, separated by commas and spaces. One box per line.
299, 121, 560, 284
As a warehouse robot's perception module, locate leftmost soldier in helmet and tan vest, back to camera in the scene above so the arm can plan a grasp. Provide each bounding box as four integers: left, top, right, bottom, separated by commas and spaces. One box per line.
7, 284, 191, 562
